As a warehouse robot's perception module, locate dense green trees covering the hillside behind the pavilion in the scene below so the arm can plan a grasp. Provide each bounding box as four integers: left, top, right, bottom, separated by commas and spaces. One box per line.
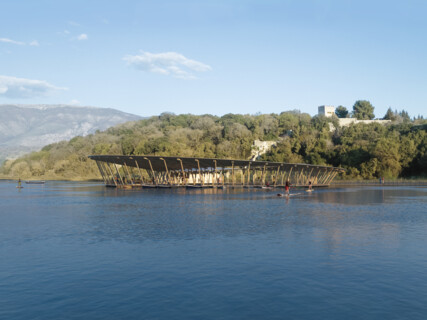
0, 111, 427, 180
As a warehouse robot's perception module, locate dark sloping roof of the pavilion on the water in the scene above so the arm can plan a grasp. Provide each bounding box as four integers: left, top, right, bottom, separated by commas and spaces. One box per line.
89, 155, 344, 172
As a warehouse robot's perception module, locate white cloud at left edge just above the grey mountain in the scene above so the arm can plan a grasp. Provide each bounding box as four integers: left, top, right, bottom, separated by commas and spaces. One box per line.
0, 76, 66, 99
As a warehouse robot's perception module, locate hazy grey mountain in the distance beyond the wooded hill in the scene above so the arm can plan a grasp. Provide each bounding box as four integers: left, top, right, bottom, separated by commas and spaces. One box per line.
0, 104, 141, 163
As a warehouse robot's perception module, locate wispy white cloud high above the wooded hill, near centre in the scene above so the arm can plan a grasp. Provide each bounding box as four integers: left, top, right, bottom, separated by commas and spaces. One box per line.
123, 51, 212, 79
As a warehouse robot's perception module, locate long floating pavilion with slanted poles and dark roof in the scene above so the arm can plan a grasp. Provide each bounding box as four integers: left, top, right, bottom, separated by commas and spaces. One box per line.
89, 155, 344, 188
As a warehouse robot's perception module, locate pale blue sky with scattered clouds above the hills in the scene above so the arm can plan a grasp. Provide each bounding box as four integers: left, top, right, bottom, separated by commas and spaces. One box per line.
0, 0, 427, 117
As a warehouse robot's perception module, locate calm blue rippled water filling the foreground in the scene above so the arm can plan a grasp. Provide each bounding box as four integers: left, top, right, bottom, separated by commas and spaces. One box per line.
0, 182, 427, 319
